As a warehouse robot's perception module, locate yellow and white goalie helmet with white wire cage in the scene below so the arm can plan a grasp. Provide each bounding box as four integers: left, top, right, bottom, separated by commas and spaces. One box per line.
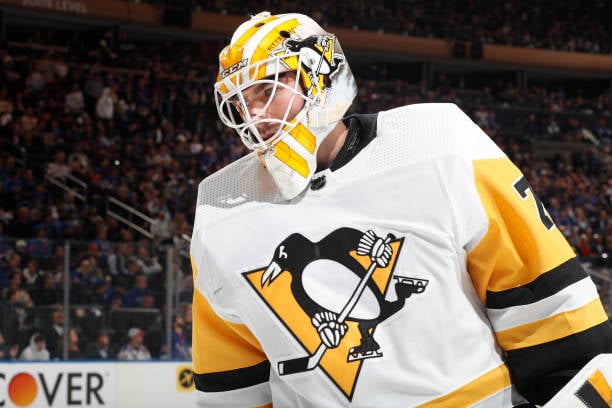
215, 12, 357, 199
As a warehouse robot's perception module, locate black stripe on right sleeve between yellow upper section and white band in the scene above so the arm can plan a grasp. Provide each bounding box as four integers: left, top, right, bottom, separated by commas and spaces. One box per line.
487, 258, 588, 309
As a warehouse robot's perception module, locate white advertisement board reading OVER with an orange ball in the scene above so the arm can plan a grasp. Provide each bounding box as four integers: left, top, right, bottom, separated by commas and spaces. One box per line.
0, 361, 194, 408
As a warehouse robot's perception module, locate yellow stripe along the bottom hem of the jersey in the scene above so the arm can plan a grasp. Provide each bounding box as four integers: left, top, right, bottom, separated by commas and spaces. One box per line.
418, 364, 512, 408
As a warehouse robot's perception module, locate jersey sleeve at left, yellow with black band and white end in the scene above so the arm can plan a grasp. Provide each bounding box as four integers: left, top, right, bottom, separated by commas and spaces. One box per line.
192, 255, 272, 407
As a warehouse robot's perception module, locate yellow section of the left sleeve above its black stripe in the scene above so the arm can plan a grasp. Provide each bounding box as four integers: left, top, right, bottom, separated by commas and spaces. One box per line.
193, 289, 266, 374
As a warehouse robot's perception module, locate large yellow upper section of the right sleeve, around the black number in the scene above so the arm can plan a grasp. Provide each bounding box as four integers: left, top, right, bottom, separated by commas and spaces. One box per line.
467, 158, 575, 303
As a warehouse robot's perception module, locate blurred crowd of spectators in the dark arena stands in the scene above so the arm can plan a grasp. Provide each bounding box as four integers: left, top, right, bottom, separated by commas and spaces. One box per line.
0, 0, 612, 360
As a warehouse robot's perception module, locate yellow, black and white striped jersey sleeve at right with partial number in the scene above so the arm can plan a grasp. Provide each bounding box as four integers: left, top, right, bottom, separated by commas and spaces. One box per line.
467, 156, 612, 404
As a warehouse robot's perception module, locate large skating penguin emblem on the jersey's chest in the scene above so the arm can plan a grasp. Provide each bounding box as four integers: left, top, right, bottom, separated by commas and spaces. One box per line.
243, 228, 428, 400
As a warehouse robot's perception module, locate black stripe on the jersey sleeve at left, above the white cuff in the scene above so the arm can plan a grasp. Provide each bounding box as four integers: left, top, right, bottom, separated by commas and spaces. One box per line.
194, 360, 270, 392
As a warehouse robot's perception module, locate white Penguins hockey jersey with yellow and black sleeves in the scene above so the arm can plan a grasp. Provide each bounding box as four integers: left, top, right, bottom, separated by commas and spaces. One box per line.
191, 104, 611, 408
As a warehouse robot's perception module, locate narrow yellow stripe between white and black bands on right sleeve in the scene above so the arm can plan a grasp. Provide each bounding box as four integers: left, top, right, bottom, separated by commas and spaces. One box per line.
496, 298, 608, 350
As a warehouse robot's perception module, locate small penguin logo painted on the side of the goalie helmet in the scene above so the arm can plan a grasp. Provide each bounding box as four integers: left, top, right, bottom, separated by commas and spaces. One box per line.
281, 32, 344, 97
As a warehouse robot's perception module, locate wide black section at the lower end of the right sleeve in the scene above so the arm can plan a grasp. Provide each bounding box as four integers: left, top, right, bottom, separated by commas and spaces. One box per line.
506, 321, 612, 405
